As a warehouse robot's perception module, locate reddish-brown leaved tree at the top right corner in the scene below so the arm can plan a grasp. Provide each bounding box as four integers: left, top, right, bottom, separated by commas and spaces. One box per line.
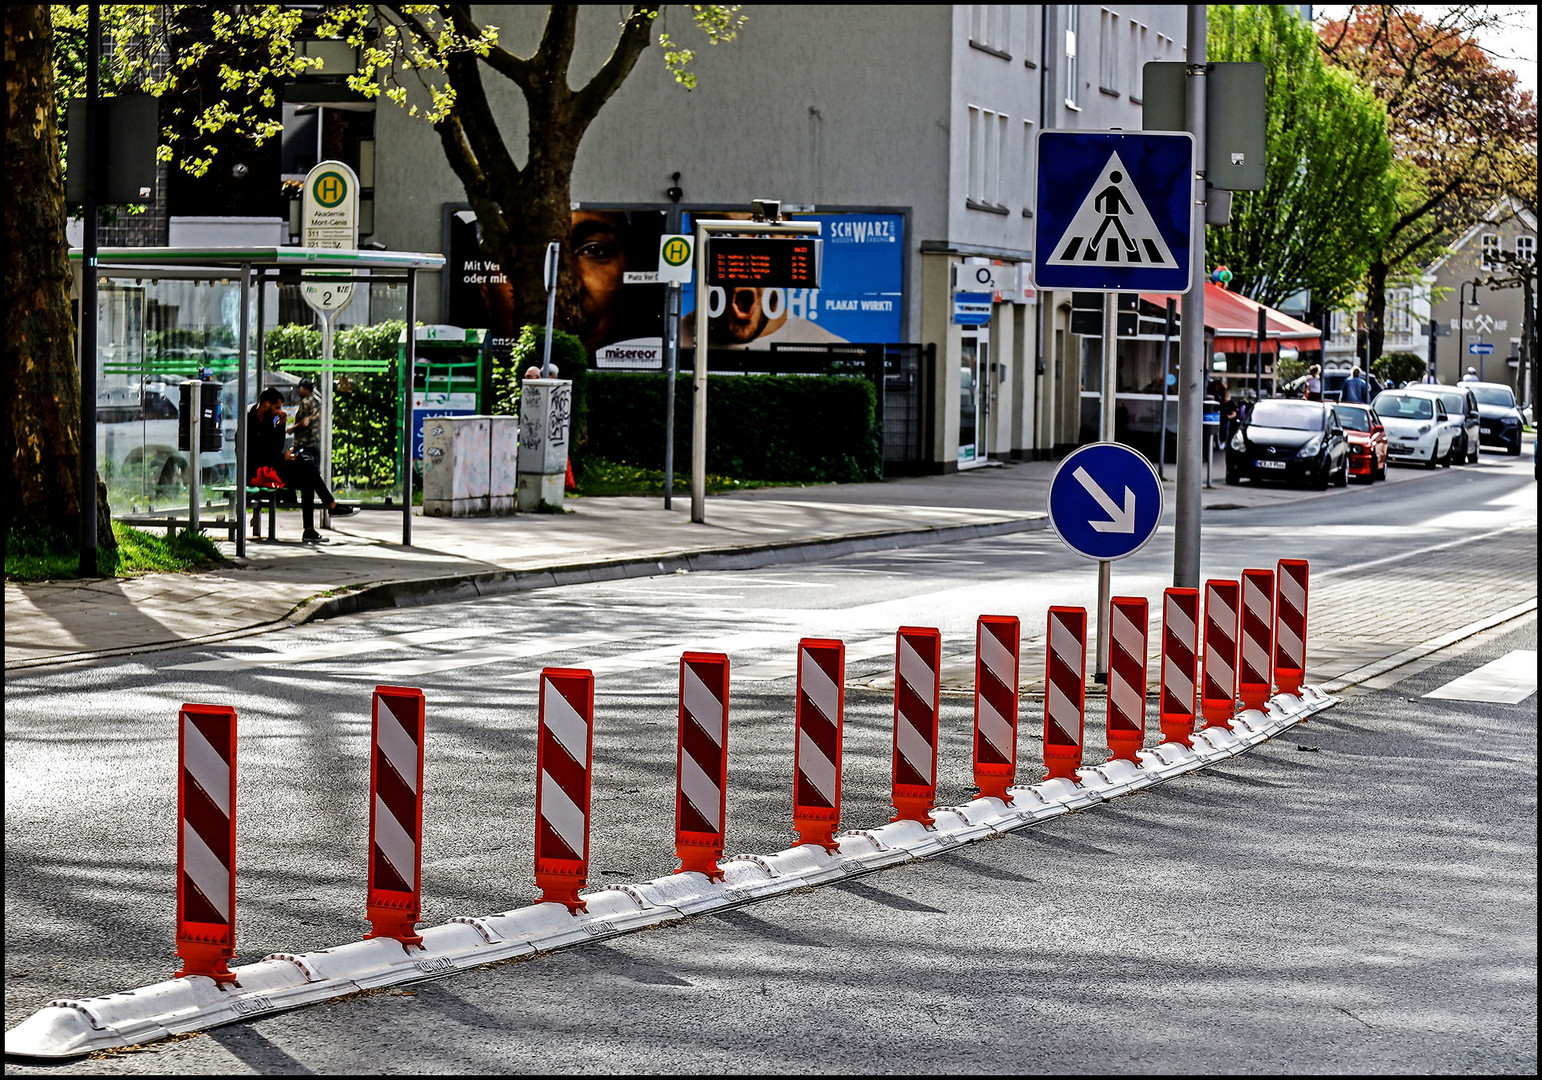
1318, 5, 1537, 361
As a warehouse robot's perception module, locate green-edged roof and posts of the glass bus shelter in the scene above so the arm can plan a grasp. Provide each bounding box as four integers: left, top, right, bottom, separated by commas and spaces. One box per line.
69, 247, 444, 557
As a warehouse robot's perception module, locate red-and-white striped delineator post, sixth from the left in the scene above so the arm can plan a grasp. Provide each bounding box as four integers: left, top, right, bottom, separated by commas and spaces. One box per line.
893, 626, 942, 827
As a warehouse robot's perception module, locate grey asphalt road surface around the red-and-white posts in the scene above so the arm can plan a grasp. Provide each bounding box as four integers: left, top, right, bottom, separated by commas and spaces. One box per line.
5, 455, 1536, 1072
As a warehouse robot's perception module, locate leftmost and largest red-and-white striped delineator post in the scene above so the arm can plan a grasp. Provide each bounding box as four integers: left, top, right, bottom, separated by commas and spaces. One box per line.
176, 705, 236, 983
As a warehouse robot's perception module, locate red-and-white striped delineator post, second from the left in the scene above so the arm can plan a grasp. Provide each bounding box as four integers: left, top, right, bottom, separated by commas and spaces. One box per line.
364, 687, 424, 946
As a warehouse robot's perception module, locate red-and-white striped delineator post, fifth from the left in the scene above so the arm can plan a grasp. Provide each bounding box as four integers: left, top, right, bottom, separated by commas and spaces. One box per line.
793, 637, 847, 852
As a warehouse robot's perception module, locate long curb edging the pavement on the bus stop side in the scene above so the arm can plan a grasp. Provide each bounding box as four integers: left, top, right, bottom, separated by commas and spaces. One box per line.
5, 514, 1049, 671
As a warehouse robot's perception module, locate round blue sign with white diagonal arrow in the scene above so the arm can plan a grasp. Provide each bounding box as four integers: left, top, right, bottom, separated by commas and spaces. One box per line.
1050, 443, 1161, 560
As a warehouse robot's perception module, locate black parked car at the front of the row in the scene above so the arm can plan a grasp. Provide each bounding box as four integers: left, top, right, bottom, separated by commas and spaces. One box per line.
1226, 398, 1349, 488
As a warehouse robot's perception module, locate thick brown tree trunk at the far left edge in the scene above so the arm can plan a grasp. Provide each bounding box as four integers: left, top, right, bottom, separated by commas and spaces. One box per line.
3, 5, 85, 542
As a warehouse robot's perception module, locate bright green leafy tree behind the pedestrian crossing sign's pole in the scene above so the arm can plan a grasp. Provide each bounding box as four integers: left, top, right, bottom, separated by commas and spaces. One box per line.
1206, 5, 1397, 307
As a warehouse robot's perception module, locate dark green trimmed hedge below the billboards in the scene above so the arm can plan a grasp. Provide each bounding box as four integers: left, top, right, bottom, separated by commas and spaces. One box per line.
588, 372, 884, 483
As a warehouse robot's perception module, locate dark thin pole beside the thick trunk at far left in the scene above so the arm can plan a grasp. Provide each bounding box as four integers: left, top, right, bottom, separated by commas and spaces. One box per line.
80, 3, 105, 577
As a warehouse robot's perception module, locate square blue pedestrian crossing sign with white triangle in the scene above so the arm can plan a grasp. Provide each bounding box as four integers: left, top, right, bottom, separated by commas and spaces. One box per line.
1033, 131, 1194, 293
